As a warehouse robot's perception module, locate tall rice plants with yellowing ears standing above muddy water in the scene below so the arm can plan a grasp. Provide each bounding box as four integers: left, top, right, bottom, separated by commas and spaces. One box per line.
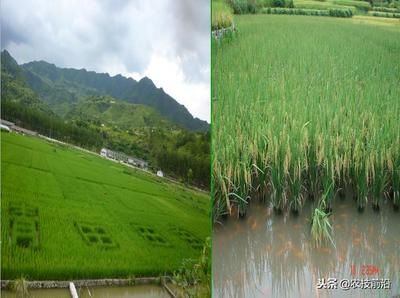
212, 15, 400, 219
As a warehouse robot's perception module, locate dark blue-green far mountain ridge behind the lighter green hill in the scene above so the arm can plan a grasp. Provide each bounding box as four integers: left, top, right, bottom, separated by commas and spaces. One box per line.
2, 51, 209, 131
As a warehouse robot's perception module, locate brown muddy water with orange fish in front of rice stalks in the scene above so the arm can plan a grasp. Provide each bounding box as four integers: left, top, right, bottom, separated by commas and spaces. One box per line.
213, 200, 400, 297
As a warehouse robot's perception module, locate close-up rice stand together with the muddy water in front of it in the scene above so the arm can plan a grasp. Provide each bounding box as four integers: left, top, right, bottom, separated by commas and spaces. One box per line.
212, 1, 400, 297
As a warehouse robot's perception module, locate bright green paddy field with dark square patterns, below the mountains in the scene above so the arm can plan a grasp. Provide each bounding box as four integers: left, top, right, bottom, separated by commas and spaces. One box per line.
1, 133, 210, 280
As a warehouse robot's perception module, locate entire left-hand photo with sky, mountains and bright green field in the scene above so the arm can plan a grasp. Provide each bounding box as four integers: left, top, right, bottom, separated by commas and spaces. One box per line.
0, 0, 212, 298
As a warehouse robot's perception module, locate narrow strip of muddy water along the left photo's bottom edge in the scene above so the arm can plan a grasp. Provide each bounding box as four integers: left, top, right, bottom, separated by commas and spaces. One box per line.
1, 285, 169, 298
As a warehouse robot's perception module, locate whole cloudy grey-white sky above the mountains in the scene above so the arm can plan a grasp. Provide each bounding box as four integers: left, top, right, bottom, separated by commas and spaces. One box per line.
1, 0, 210, 122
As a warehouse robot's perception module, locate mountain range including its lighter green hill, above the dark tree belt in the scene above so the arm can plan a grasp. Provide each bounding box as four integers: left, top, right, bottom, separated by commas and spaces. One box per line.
1, 50, 209, 131
